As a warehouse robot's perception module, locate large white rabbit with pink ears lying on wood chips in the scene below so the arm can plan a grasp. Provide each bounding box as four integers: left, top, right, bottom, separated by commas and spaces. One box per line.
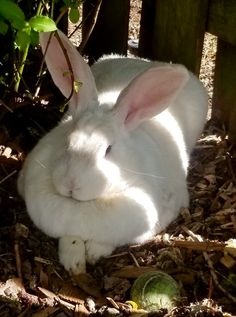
18, 32, 207, 274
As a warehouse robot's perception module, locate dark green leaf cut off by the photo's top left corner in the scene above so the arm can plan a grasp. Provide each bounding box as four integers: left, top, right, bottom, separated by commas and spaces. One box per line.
0, 0, 25, 30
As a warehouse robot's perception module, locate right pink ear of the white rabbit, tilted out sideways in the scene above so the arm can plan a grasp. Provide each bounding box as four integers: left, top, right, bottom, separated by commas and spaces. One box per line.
114, 65, 189, 129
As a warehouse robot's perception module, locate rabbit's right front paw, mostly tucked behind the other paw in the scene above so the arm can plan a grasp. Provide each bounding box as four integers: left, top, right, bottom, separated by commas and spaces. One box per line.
85, 240, 114, 264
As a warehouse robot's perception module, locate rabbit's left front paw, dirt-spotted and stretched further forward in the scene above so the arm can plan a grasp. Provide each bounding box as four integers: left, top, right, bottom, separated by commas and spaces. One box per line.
59, 236, 86, 275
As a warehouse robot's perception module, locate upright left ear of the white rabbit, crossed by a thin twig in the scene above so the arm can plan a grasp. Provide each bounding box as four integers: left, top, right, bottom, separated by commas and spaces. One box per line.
40, 31, 97, 110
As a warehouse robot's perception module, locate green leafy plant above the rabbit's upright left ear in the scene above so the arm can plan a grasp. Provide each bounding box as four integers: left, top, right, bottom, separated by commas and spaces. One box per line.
0, 0, 81, 92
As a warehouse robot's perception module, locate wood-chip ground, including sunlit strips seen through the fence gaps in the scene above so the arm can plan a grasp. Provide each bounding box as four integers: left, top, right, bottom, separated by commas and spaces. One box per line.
0, 1, 236, 317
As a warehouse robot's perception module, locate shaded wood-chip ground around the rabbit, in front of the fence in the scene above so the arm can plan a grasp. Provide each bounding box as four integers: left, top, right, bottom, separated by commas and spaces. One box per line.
0, 107, 236, 316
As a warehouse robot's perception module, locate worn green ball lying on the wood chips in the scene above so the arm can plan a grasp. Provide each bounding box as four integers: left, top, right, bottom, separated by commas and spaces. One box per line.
131, 271, 180, 311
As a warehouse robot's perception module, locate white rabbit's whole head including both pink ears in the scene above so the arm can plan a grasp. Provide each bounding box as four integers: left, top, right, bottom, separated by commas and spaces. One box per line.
40, 32, 189, 201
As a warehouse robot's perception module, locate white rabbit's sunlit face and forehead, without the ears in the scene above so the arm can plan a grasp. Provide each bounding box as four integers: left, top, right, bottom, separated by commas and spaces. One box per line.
52, 110, 121, 201
